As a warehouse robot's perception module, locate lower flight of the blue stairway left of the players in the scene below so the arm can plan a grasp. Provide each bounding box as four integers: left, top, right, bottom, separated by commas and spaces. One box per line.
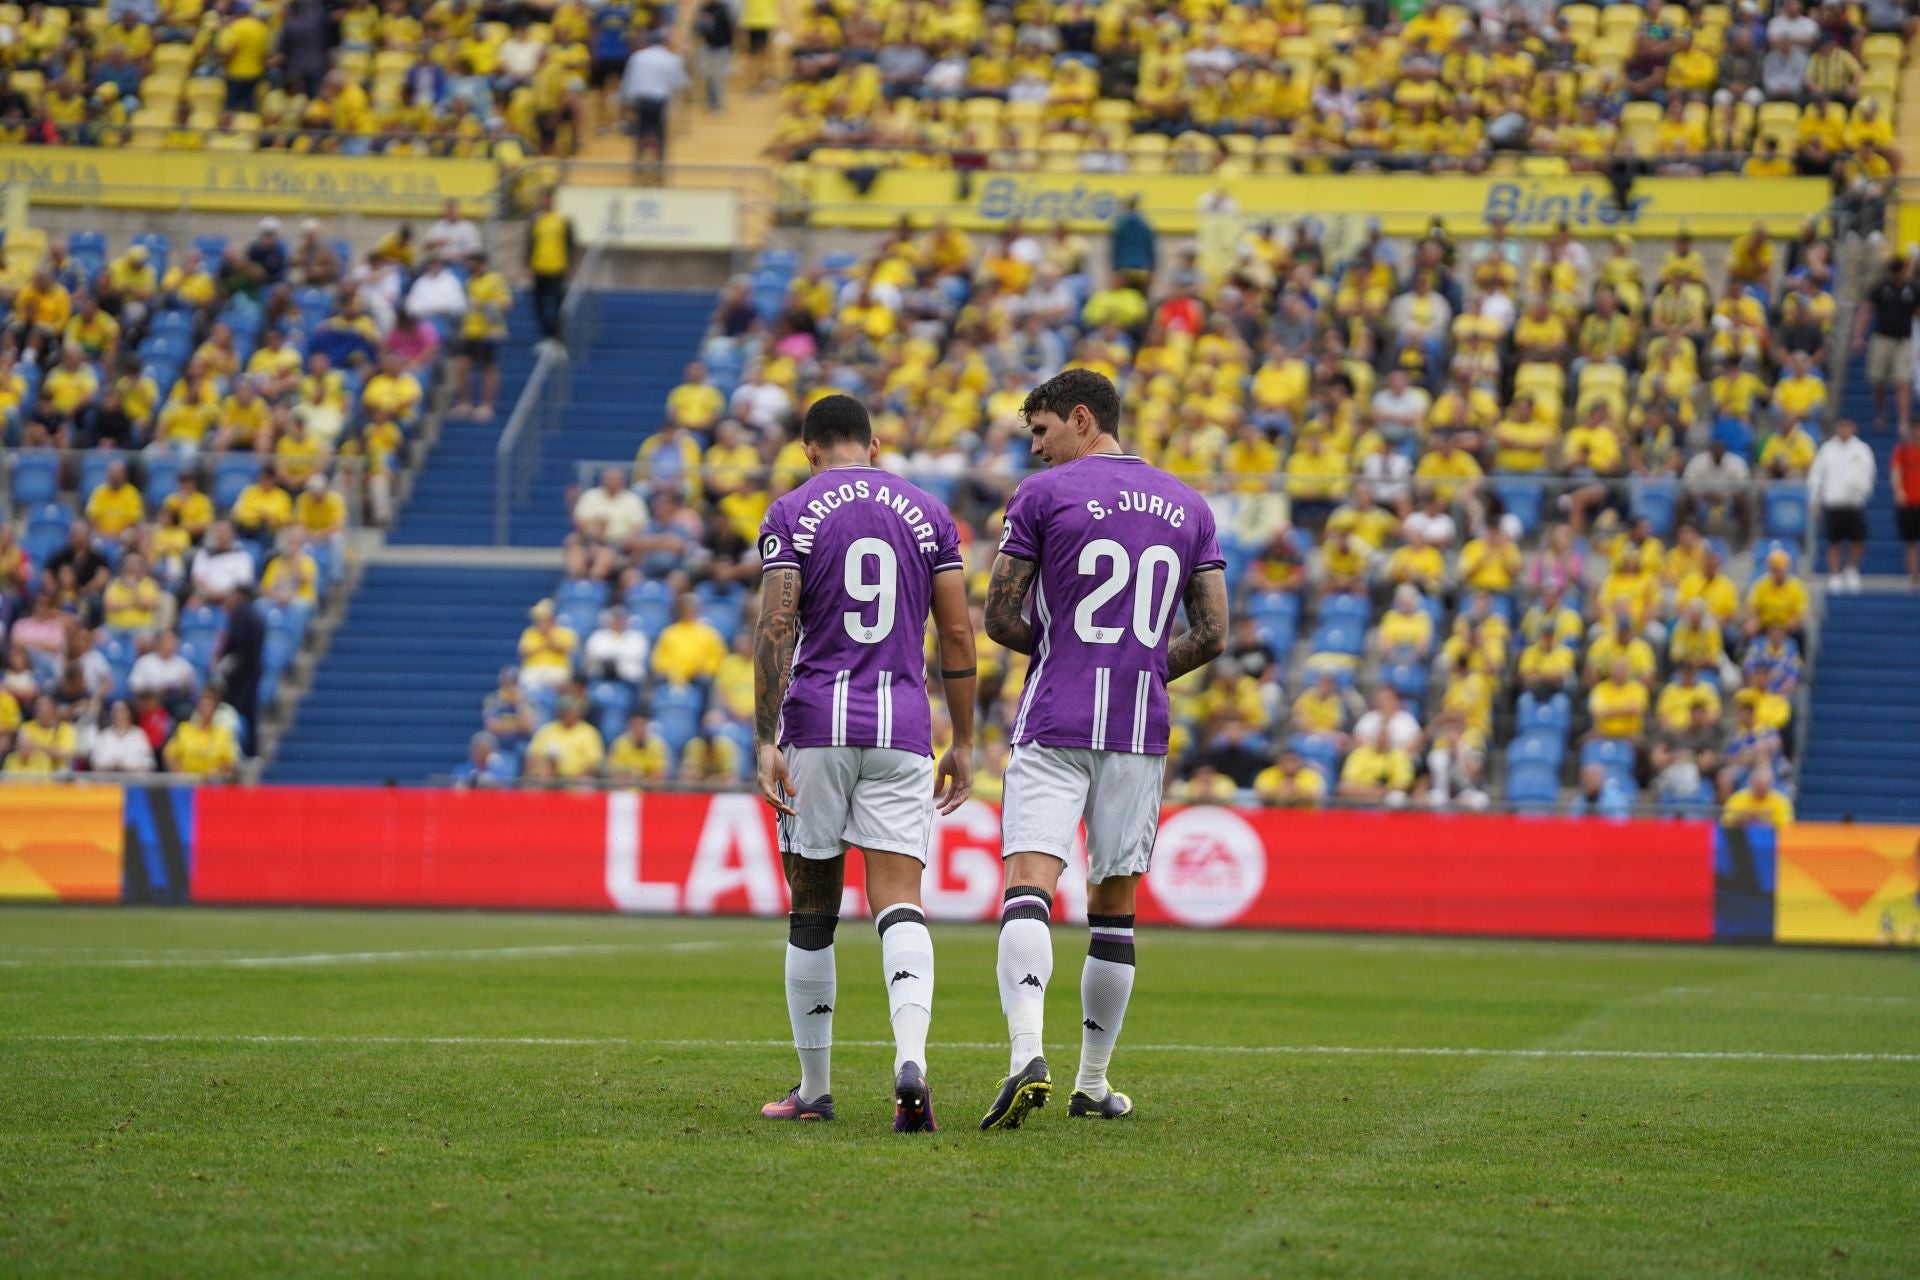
267, 564, 555, 785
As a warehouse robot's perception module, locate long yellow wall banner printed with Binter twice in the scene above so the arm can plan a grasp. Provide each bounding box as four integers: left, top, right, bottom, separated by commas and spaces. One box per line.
806, 165, 1828, 238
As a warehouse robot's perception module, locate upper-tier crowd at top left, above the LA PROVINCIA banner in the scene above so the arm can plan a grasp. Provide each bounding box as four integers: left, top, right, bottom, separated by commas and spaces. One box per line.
0, 0, 670, 161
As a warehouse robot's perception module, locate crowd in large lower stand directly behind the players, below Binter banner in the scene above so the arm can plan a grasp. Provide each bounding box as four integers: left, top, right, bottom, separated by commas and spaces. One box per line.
472, 188, 1853, 832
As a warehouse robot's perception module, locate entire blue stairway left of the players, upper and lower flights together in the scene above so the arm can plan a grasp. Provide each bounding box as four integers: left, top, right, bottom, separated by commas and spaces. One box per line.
265, 292, 712, 783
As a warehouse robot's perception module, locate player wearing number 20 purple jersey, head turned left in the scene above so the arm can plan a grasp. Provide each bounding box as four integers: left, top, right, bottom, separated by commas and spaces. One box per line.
979, 368, 1227, 1128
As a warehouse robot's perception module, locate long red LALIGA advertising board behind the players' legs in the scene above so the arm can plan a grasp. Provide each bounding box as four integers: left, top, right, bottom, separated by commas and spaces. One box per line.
194, 789, 1715, 938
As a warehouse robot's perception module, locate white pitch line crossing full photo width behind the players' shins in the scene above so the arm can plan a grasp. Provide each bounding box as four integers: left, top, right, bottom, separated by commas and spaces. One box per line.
0, 1032, 1920, 1063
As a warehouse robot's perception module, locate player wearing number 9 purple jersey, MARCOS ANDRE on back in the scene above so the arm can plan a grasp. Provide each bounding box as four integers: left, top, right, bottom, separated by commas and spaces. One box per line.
753, 395, 973, 1132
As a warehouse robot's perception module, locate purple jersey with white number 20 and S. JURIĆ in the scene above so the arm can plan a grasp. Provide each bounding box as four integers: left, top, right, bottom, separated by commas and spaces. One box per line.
1000, 453, 1227, 756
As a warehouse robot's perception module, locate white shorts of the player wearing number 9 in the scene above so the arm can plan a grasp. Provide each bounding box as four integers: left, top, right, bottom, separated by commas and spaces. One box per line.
780, 747, 933, 865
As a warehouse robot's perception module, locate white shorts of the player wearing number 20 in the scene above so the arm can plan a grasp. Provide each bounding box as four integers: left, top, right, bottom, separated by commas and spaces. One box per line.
1000, 743, 1167, 885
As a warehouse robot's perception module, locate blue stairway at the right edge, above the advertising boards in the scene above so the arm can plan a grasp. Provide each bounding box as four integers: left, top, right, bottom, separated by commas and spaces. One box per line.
1795, 591, 1920, 821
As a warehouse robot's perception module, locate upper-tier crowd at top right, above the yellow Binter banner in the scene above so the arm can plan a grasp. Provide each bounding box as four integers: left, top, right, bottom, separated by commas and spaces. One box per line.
774, 0, 1912, 197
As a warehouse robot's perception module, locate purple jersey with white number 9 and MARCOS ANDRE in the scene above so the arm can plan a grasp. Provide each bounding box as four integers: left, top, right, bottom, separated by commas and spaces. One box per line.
760, 466, 962, 756
